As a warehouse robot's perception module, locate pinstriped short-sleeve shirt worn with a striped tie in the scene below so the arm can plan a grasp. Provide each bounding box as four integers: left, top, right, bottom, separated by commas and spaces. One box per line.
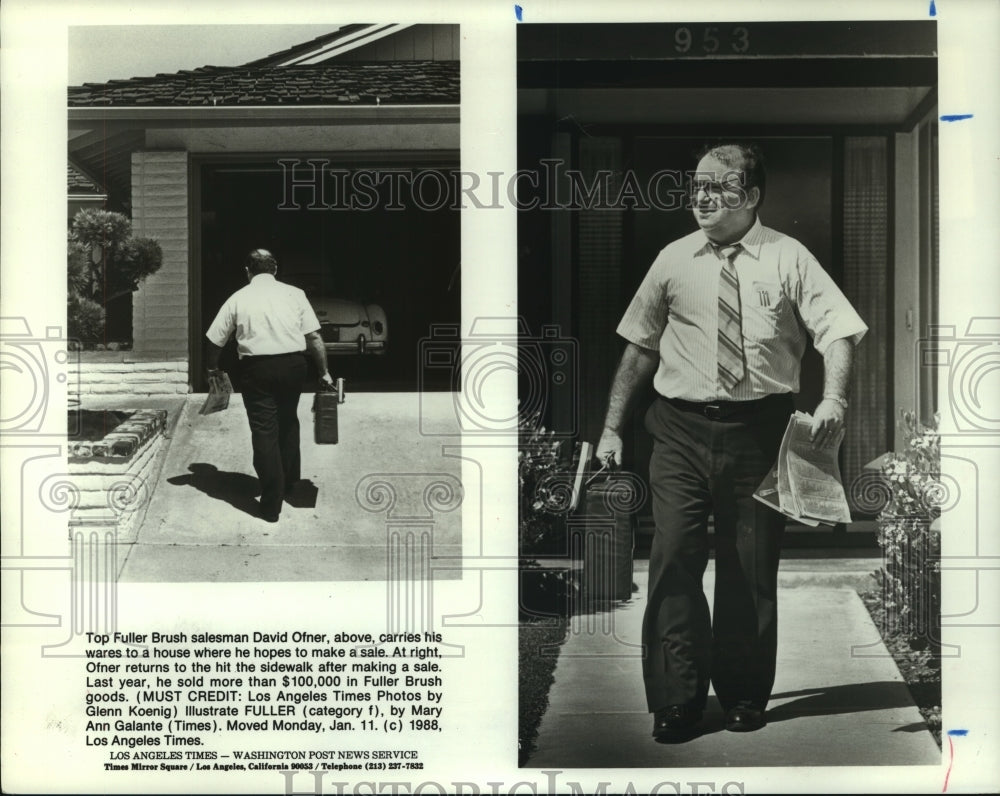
618, 220, 868, 401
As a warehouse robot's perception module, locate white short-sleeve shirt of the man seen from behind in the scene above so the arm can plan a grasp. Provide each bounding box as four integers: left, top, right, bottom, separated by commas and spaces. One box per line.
205, 274, 319, 359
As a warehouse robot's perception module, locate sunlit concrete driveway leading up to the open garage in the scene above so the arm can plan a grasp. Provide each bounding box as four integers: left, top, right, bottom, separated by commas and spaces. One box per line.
120, 393, 462, 582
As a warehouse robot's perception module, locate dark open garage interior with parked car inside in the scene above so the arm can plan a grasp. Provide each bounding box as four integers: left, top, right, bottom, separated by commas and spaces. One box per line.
192, 155, 461, 392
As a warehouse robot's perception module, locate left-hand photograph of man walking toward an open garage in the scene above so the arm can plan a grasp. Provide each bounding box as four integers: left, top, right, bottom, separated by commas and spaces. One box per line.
67, 24, 462, 581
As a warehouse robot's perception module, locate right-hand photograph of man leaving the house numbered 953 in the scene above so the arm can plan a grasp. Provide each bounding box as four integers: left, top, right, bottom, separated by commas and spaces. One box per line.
517, 17, 996, 768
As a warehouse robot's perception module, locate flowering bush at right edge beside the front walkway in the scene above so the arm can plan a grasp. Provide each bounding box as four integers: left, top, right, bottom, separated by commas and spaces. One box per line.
876, 412, 945, 646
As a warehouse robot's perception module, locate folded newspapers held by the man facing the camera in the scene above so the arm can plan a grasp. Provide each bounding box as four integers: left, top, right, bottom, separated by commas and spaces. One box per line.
754, 412, 851, 527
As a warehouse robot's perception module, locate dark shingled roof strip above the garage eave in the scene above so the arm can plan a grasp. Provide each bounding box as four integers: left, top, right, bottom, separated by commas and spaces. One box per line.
69, 61, 459, 107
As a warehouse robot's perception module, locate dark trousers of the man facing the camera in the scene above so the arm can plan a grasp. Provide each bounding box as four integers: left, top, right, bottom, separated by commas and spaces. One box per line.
642, 396, 793, 711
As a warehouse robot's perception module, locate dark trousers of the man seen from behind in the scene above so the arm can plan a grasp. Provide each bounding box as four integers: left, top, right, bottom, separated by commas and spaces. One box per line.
240, 353, 306, 516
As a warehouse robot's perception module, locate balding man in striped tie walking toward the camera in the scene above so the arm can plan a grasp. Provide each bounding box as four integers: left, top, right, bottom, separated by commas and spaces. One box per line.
597, 144, 868, 743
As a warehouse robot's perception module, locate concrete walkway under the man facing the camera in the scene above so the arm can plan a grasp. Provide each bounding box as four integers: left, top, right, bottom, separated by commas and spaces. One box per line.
525, 562, 941, 769
